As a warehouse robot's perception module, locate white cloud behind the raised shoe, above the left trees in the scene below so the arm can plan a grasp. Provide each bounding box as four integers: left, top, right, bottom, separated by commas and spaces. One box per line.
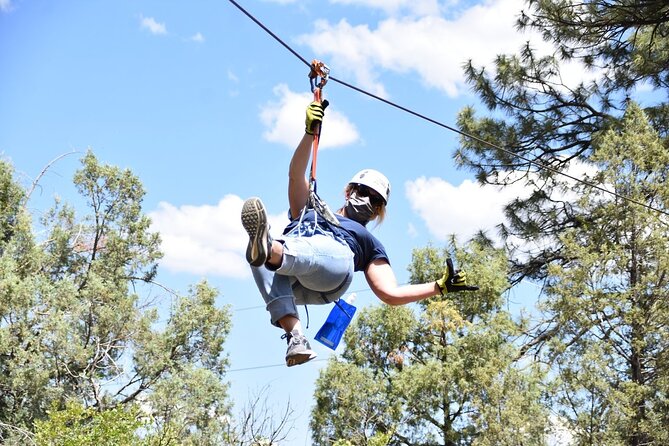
149, 195, 288, 278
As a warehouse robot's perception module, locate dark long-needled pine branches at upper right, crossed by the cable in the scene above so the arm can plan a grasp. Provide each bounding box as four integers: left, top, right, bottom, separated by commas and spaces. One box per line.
456, 0, 669, 281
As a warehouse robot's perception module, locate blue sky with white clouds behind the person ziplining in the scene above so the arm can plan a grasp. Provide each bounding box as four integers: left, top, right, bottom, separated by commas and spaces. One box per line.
0, 0, 583, 445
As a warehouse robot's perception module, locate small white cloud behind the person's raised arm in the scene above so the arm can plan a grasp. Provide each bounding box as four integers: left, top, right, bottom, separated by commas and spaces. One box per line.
260, 84, 360, 149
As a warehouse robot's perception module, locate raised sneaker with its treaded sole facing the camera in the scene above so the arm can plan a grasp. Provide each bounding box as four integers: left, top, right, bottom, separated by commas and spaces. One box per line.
242, 197, 272, 266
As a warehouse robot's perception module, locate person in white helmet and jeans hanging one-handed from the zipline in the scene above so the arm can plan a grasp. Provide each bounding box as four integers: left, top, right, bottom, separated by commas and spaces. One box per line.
241, 61, 478, 367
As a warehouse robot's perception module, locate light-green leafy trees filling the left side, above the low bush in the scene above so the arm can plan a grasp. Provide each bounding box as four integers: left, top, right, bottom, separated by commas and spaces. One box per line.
0, 152, 230, 444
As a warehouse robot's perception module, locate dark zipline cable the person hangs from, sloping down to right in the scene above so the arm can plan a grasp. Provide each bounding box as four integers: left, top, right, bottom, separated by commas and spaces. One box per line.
228, 0, 669, 216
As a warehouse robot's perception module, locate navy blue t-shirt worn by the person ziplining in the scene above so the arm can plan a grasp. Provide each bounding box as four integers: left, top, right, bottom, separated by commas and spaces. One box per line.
283, 209, 390, 271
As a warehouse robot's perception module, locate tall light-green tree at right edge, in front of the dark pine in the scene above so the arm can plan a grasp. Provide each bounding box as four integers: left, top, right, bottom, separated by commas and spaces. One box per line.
528, 103, 669, 446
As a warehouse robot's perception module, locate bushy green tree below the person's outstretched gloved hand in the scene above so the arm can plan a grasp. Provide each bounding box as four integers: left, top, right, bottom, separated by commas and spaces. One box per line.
311, 245, 548, 446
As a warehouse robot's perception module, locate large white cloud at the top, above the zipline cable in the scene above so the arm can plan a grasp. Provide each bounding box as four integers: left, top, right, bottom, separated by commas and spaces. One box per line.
299, 0, 560, 97
